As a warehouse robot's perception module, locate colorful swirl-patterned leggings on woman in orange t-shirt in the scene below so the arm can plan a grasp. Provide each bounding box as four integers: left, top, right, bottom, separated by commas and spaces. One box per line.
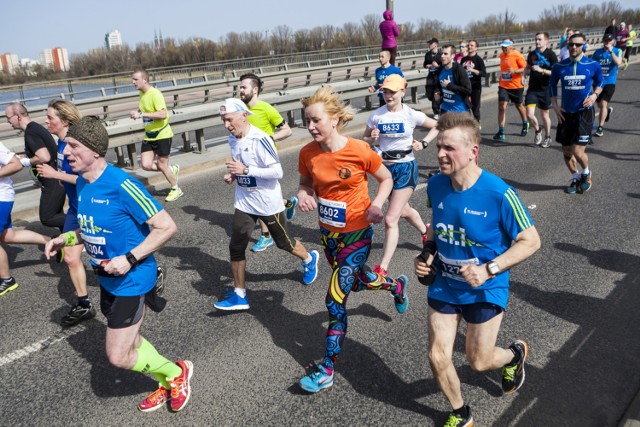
320, 226, 402, 369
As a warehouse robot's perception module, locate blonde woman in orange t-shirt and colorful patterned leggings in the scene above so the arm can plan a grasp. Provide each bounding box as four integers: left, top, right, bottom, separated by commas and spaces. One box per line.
298, 86, 409, 393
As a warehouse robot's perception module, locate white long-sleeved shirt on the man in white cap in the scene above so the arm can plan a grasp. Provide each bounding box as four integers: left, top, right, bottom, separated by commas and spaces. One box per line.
229, 125, 284, 216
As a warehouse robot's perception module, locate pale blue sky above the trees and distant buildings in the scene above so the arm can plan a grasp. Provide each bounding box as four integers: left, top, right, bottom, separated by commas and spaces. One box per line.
0, 0, 638, 59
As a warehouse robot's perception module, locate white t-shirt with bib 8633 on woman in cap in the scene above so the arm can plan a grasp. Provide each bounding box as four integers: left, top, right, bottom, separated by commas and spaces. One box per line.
367, 104, 427, 163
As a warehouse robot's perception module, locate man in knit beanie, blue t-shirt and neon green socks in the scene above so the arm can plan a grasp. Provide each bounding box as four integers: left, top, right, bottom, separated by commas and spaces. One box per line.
45, 116, 193, 412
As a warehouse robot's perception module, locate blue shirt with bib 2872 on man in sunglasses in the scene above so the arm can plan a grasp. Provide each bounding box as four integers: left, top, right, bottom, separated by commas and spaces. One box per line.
549, 55, 604, 113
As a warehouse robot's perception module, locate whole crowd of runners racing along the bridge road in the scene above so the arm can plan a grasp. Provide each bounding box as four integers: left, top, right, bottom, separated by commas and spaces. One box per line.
0, 15, 635, 427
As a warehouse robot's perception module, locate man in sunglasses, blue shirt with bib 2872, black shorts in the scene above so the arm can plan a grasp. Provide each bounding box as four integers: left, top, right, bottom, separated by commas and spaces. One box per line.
549, 33, 604, 194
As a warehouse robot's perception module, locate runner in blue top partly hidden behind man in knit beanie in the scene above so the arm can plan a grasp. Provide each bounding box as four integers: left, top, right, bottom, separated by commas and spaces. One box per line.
37, 99, 96, 326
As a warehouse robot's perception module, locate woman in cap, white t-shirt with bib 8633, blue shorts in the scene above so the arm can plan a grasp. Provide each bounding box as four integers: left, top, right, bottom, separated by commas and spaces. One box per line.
363, 75, 440, 276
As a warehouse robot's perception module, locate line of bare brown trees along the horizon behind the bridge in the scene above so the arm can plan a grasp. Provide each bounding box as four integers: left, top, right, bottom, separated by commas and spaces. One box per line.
0, 1, 640, 85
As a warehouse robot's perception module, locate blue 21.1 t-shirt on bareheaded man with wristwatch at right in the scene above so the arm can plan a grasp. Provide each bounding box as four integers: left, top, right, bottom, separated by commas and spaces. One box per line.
427, 170, 533, 309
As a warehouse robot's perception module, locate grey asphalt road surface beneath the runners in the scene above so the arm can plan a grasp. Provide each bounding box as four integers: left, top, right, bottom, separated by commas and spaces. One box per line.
0, 66, 640, 427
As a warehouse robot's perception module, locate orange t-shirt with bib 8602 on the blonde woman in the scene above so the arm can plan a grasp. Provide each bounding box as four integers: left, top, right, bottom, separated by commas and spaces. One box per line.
298, 137, 382, 233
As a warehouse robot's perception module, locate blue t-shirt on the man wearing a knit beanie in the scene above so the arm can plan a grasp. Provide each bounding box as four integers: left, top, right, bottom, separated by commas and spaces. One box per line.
76, 165, 162, 296
